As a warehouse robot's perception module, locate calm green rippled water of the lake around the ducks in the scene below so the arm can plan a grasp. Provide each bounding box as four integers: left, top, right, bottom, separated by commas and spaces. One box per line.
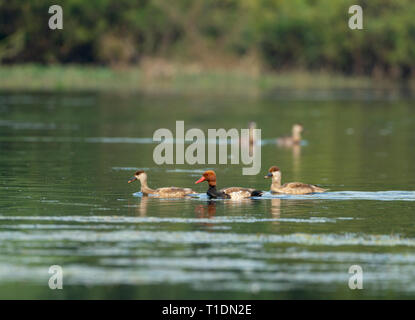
0, 92, 415, 299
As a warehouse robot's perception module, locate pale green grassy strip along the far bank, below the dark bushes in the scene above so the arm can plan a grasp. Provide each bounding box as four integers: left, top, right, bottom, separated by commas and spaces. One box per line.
0, 62, 415, 95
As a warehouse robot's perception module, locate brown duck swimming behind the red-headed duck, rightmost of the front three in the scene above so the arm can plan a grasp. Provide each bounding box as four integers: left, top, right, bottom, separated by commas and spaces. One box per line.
264, 166, 328, 194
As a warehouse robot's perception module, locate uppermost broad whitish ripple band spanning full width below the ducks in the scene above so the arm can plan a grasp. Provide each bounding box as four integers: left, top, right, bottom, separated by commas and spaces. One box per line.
0, 230, 415, 247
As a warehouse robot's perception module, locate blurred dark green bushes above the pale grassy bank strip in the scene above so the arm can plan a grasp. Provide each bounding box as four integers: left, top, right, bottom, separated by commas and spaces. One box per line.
0, 0, 415, 78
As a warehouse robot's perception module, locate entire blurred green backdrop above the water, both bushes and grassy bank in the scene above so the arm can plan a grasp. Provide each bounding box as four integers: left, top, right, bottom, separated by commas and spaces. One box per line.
0, 0, 415, 89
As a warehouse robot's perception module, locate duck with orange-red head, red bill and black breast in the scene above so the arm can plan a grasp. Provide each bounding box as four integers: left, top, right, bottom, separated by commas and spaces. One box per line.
195, 170, 263, 200
